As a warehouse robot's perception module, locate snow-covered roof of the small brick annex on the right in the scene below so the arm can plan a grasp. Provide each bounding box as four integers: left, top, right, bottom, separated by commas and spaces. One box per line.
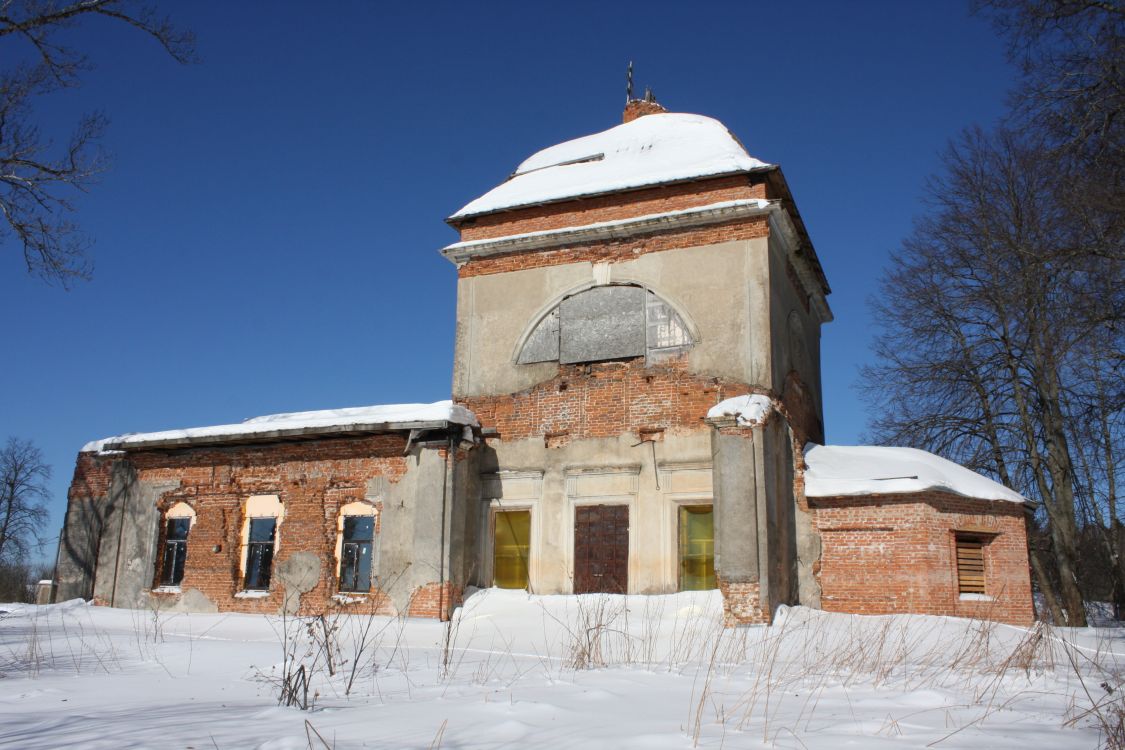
804, 443, 1027, 503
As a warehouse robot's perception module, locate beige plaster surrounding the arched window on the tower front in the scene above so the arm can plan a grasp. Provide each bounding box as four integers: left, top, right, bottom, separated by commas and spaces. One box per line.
453, 237, 773, 397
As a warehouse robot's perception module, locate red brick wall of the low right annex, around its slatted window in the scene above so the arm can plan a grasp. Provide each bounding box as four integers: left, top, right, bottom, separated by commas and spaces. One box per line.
809, 491, 1034, 624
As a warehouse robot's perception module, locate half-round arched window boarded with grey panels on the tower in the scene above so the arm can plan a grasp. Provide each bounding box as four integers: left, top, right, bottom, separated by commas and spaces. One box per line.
518, 284, 695, 364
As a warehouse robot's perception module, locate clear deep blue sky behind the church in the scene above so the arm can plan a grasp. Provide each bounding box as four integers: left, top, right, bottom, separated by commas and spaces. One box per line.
0, 0, 1015, 558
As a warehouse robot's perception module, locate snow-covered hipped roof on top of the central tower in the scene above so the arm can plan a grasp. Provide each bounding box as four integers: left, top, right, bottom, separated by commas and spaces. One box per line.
450, 112, 773, 220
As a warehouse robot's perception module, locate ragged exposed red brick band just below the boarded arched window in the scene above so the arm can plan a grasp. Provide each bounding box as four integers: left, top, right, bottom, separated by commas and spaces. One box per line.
457, 356, 749, 444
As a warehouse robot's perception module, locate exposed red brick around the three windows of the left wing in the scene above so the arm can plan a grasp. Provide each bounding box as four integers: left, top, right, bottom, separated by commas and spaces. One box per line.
70, 434, 423, 613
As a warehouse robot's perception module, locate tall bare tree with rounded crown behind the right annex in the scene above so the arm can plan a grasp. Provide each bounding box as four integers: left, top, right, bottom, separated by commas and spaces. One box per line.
864, 129, 1125, 624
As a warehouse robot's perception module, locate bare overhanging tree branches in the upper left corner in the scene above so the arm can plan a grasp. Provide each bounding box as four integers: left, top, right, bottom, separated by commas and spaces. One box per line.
0, 0, 195, 287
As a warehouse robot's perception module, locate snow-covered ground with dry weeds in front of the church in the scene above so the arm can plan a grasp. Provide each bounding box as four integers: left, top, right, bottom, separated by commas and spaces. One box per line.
0, 589, 1125, 750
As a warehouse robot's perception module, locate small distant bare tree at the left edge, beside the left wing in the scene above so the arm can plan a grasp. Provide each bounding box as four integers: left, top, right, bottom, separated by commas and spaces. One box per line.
0, 437, 51, 564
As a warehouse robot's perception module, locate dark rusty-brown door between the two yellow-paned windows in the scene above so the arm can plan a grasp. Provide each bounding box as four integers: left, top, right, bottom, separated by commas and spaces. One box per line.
574, 505, 629, 594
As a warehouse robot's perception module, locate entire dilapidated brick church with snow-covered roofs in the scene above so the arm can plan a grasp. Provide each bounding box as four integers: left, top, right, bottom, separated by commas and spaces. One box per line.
55, 101, 1034, 624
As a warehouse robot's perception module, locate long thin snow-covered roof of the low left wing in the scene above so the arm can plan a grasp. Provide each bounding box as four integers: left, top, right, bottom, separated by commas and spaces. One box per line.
82, 400, 479, 452
